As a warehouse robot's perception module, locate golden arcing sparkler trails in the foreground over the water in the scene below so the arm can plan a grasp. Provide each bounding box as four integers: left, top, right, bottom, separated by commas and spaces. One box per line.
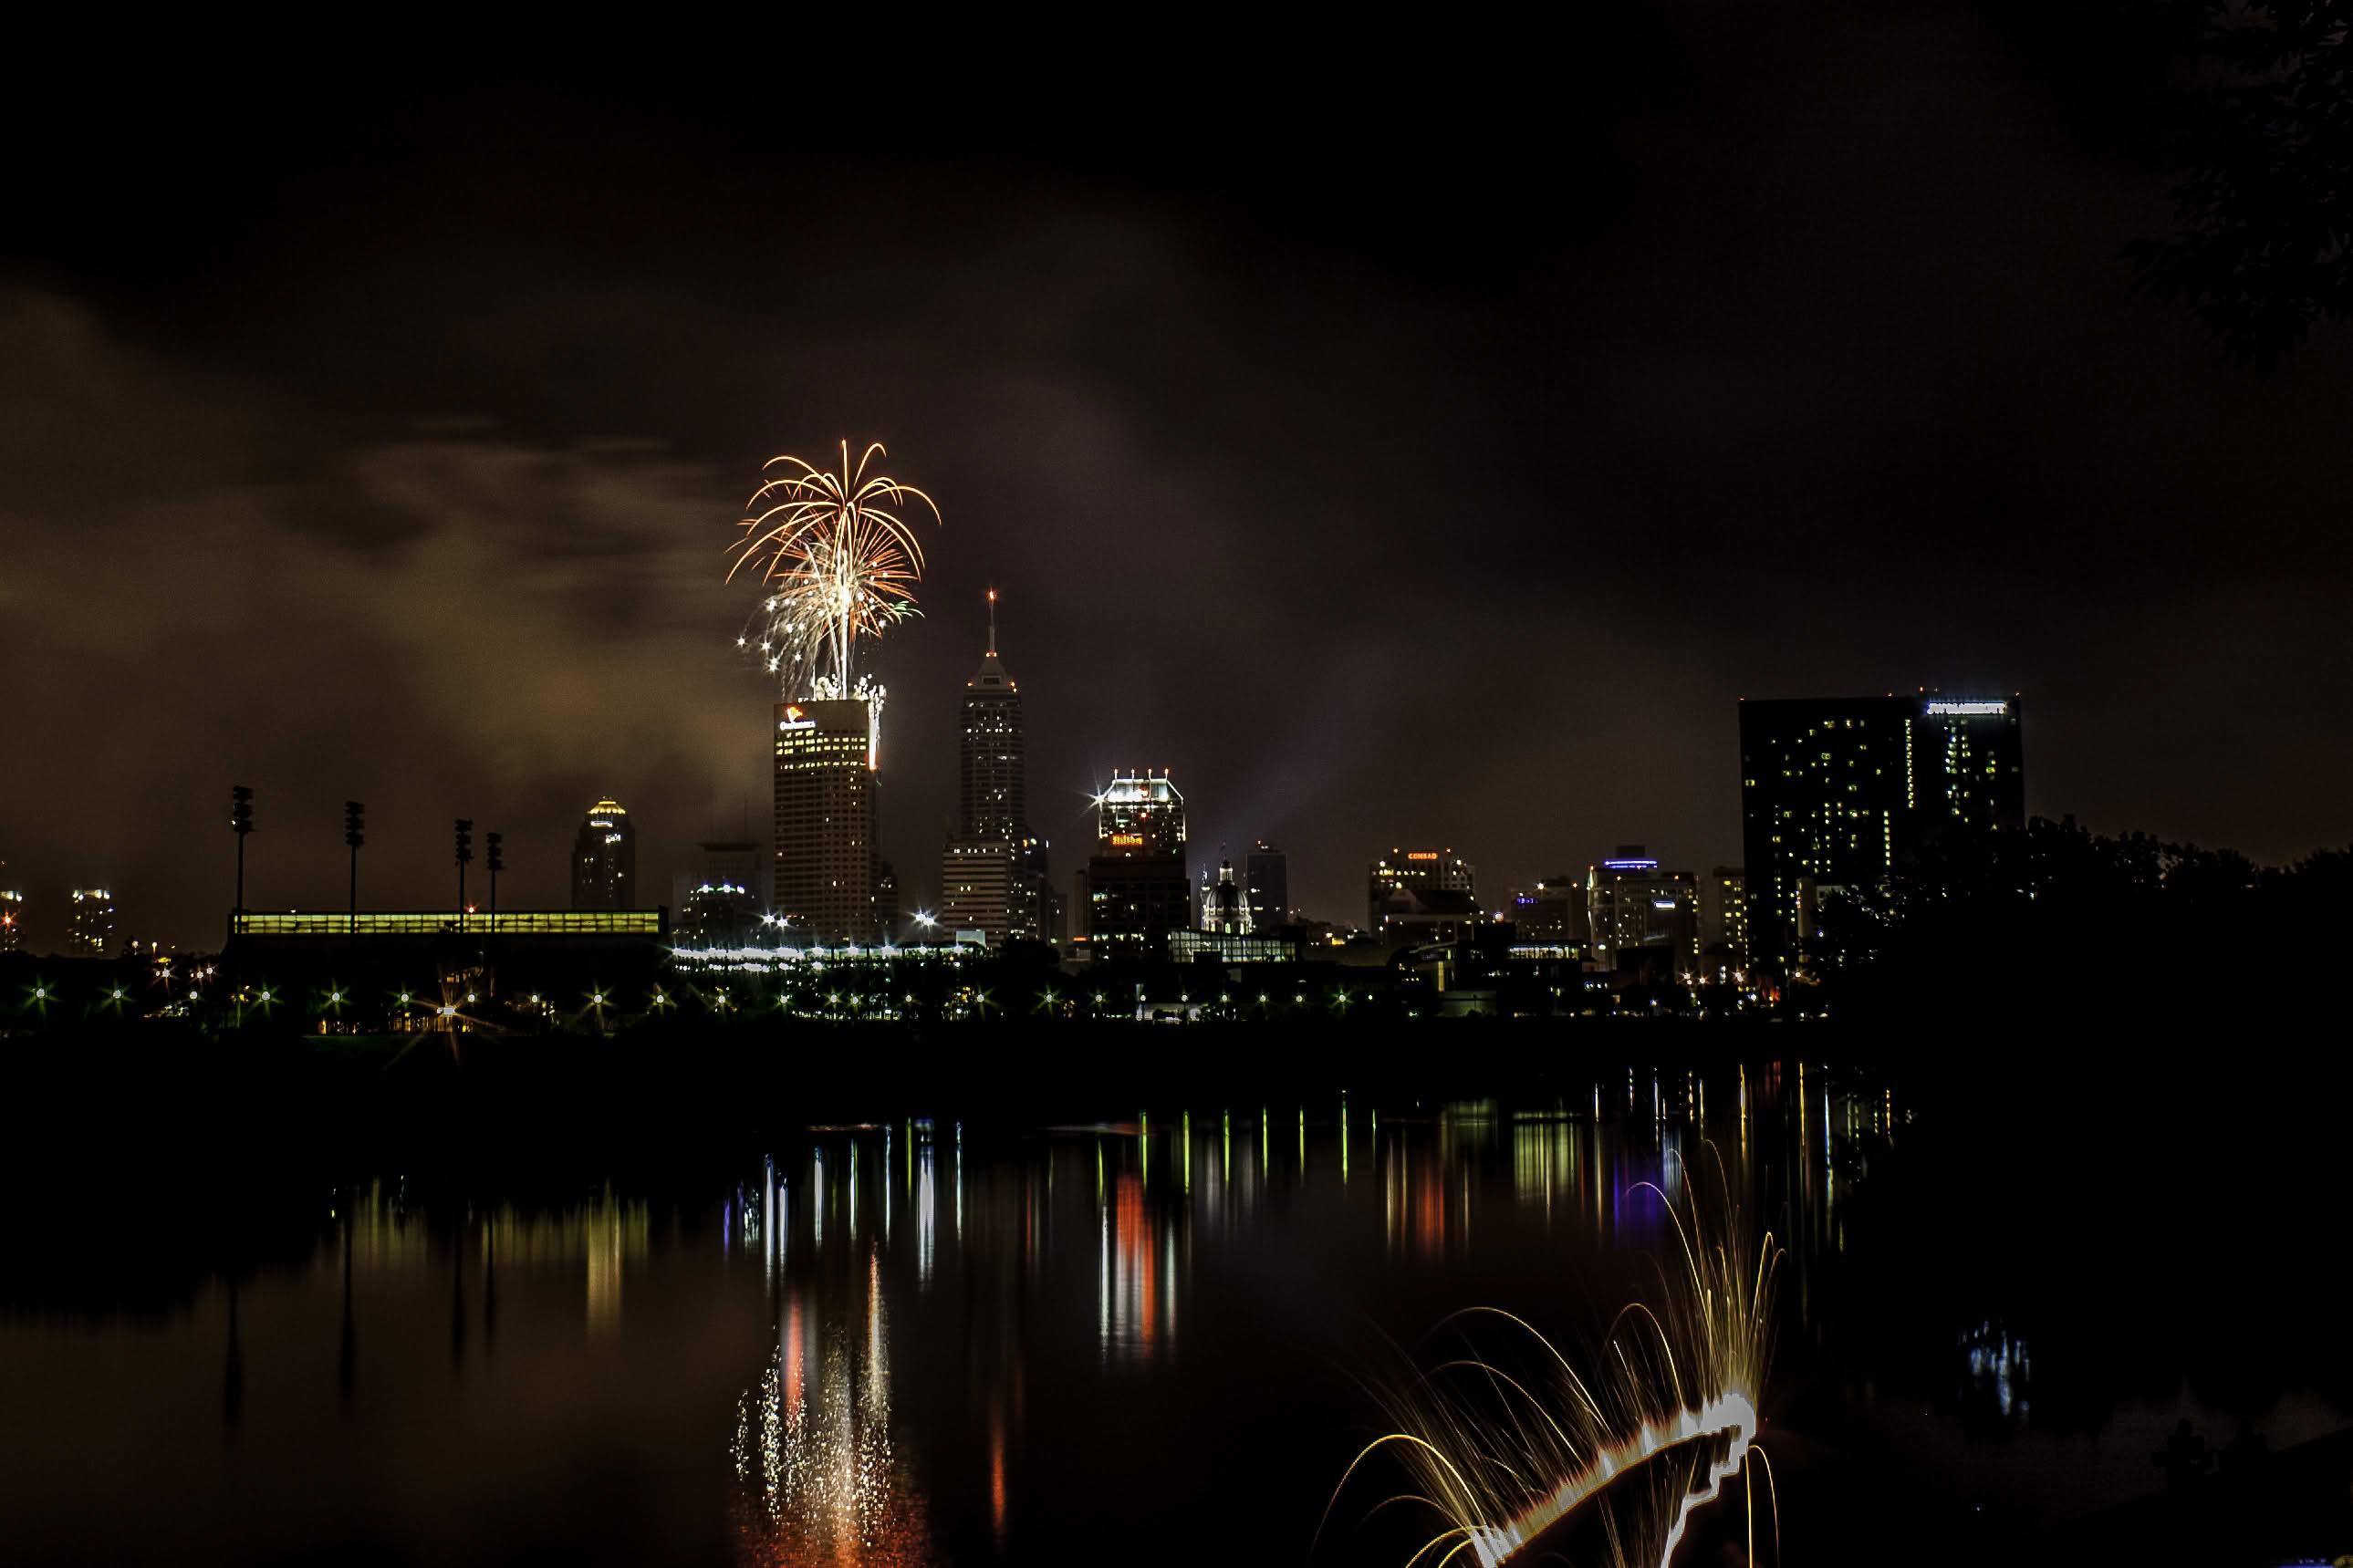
1325, 1142, 1779, 1568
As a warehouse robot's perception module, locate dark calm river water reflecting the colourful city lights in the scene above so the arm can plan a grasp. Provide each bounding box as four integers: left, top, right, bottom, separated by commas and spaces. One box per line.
0, 1060, 2353, 1565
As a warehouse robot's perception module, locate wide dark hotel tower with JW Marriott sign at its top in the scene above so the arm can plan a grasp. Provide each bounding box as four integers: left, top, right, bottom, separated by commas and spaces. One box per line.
1741, 691, 2026, 973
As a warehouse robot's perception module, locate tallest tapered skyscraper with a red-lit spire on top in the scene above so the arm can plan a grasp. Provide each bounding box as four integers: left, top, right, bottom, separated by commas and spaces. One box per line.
939, 587, 1049, 948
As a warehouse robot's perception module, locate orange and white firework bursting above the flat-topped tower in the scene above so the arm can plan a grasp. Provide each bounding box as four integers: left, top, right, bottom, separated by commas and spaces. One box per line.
727, 440, 939, 698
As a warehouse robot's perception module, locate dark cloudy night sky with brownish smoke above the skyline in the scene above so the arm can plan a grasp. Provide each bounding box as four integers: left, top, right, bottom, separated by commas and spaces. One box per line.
0, 3, 2353, 948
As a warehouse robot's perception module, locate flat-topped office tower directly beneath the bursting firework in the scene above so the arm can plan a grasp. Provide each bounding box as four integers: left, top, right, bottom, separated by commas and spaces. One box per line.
772, 698, 882, 942
